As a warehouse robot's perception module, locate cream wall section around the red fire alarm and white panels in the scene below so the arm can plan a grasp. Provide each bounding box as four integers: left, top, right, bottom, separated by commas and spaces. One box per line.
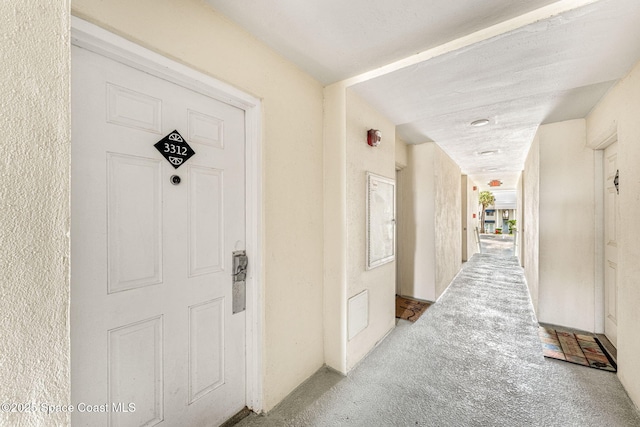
346, 90, 396, 370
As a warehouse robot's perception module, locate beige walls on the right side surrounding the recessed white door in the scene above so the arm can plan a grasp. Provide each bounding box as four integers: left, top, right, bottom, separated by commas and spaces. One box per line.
522, 61, 640, 406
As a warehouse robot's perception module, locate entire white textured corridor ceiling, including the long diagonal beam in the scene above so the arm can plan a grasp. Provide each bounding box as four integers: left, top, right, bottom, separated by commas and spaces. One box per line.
206, 0, 640, 189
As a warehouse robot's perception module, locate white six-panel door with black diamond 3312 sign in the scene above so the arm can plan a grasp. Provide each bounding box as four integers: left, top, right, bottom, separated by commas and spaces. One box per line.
71, 47, 246, 426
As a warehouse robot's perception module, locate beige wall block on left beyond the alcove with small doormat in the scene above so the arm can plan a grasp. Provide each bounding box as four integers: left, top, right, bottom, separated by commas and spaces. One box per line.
398, 142, 462, 301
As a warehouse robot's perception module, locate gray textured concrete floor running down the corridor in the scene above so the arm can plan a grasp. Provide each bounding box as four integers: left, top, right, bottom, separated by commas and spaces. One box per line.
238, 248, 640, 427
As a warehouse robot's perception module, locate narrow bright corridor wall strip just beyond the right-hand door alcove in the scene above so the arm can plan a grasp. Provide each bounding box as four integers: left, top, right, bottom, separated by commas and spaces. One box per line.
520, 135, 540, 314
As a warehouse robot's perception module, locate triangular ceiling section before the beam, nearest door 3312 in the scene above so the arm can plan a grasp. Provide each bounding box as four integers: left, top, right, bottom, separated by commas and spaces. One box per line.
206, 0, 554, 84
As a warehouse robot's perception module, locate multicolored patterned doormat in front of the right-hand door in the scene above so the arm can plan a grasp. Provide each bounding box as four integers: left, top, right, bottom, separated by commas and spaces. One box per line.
538, 326, 616, 372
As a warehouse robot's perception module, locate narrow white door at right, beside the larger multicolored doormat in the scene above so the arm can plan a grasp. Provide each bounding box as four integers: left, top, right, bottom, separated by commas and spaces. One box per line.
604, 142, 619, 347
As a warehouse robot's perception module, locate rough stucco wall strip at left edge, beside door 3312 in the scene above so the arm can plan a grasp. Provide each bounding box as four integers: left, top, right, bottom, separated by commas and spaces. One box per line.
0, 1, 70, 426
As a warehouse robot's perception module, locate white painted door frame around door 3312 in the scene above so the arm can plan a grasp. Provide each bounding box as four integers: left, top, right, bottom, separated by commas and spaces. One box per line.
71, 16, 263, 412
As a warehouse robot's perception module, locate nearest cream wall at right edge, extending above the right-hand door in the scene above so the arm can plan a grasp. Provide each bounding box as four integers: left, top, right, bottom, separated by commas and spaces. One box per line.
587, 60, 640, 412
